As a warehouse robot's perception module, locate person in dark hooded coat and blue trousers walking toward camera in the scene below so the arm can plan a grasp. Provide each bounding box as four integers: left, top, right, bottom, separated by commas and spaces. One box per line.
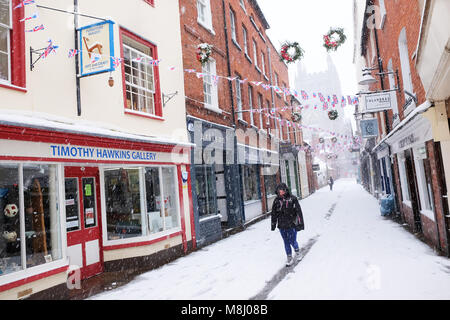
271, 183, 305, 267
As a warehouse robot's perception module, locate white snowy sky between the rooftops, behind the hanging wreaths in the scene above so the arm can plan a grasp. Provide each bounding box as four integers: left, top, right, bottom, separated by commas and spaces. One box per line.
258, 0, 358, 129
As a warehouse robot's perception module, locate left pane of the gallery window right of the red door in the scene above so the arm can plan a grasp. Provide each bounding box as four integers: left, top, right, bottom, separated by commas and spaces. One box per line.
105, 168, 142, 240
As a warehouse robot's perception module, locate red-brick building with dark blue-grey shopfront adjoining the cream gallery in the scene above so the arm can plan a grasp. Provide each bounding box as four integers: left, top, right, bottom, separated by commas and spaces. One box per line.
180, 0, 310, 245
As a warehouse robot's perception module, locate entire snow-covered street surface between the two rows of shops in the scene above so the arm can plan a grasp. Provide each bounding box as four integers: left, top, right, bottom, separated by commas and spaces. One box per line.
90, 179, 450, 300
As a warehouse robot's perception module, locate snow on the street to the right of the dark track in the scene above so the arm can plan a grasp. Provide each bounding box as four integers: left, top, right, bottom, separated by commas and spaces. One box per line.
268, 180, 450, 300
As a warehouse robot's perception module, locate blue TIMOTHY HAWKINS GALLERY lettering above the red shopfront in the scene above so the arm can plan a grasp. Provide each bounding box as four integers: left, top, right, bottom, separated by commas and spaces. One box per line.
50, 145, 157, 161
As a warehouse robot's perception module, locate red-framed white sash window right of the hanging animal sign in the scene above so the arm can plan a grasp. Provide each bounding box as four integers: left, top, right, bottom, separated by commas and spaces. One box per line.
121, 30, 162, 117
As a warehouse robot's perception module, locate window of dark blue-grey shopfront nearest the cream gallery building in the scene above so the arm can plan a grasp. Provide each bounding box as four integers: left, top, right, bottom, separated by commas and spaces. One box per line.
195, 165, 217, 217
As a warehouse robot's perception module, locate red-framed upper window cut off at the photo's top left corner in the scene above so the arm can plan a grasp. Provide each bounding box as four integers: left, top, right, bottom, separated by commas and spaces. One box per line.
0, 0, 25, 87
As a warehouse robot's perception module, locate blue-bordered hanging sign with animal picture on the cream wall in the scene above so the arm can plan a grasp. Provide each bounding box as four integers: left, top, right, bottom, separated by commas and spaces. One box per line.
79, 20, 114, 77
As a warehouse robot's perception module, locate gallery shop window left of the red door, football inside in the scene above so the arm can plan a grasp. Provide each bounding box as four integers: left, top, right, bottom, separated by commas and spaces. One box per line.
0, 164, 62, 276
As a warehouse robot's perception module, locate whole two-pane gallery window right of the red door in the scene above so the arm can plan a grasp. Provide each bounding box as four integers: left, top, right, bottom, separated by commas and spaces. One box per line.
104, 167, 180, 240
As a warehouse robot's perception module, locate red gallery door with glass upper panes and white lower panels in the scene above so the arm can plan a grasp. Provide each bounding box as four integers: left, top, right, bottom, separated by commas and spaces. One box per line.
64, 167, 103, 280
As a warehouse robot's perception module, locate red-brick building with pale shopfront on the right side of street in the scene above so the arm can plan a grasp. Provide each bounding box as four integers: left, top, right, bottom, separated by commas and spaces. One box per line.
361, 0, 449, 253
